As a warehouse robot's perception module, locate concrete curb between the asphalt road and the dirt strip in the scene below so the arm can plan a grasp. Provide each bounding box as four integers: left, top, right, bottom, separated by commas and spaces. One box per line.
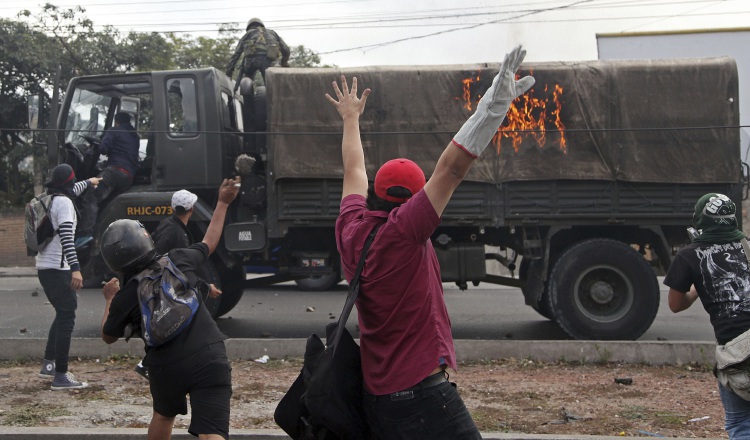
0, 337, 716, 365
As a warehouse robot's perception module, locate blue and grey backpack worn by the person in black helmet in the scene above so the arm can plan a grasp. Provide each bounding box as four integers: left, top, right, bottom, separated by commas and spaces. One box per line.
136, 255, 200, 347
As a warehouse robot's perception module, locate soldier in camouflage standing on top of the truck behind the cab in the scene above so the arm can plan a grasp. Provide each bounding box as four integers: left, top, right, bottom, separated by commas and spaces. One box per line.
225, 18, 290, 83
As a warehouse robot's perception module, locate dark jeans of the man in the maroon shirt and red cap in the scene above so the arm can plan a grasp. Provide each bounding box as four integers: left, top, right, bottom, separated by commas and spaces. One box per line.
364, 382, 482, 440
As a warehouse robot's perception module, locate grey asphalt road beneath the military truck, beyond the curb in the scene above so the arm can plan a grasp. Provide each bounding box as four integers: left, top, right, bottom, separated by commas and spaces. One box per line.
0, 276, 714, 342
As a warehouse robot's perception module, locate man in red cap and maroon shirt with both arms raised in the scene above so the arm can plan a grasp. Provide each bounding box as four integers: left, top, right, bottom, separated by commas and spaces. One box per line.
326, 47, 534, 440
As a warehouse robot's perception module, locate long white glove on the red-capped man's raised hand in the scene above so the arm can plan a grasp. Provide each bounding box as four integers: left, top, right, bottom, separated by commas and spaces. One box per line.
453, 46, 534, 158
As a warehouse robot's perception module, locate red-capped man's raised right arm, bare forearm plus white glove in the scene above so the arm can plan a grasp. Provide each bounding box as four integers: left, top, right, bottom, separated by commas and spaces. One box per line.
424, 46, 534, 215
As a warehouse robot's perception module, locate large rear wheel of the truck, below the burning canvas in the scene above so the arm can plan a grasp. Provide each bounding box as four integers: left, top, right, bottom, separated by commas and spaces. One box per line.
548, 239, 659, 340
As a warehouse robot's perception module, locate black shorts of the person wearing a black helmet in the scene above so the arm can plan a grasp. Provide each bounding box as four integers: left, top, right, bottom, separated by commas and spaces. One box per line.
148, 341, 232, 438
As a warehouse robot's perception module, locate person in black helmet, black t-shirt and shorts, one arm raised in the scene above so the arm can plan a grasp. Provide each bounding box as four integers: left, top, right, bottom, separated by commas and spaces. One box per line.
101, 178, 240, 440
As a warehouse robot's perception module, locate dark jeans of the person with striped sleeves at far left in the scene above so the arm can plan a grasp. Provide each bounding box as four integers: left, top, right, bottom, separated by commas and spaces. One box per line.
37, 269, 78, 373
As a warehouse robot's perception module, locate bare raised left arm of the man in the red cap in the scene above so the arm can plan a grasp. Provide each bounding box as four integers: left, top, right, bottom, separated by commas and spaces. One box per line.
326, 75, 370, 198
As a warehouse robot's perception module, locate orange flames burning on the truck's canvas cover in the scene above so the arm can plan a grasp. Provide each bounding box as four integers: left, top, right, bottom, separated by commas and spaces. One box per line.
461, 72, 568, 154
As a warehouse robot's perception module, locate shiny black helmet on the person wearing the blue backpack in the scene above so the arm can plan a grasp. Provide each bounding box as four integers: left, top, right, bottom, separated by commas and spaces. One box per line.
101, 219, 156, 273
